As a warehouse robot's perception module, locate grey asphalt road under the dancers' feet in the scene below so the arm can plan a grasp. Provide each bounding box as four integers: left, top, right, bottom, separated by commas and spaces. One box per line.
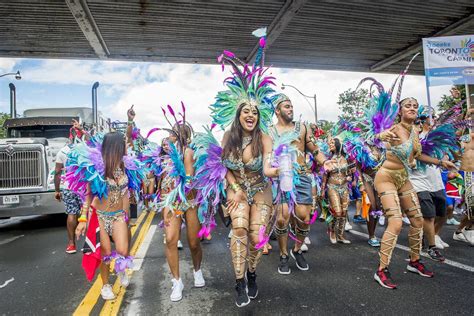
0, 207, 474, 315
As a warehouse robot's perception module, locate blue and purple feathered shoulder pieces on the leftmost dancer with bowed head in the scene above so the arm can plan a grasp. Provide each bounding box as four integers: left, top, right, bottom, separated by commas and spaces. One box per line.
65, 136, 145, 199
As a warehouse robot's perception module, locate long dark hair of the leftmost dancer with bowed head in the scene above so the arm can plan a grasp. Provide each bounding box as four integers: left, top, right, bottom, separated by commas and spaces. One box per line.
102, 132, 126, 179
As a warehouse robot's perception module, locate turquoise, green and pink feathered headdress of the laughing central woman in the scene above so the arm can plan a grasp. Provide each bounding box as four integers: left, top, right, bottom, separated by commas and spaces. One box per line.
209, 29, 275, 132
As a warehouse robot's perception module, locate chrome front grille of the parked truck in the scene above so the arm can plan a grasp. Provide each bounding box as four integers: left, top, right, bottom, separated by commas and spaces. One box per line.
0, 150, 43, 189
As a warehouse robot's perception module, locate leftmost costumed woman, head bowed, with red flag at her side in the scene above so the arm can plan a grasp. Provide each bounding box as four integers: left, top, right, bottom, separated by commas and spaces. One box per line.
66, 132, 144, 300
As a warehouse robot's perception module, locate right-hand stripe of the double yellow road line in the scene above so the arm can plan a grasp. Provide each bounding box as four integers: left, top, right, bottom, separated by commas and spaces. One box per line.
100, 212, 156, 316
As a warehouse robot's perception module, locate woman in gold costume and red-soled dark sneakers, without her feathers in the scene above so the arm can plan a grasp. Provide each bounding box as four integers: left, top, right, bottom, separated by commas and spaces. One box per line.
374, 98, 454, 289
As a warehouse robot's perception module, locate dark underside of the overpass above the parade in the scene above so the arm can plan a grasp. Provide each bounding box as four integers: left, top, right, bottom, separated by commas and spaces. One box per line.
0, 0, 474, 74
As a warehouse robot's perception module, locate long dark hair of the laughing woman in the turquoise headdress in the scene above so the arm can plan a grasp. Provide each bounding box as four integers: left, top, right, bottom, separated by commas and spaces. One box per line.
223, 103, 263, 159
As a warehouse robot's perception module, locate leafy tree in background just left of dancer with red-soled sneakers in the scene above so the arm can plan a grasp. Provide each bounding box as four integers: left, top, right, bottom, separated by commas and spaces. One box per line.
337, 89, 369, 120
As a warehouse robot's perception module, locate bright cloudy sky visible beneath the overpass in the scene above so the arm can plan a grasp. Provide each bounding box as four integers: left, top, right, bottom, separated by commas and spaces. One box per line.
0, 58, 449, 141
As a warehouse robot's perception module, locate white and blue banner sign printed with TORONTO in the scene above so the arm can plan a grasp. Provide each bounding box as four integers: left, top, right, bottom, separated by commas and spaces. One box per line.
423, 35, 474, 88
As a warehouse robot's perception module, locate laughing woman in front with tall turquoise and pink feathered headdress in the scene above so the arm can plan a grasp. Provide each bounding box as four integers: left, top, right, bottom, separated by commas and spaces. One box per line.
195, 30, 278, 307
